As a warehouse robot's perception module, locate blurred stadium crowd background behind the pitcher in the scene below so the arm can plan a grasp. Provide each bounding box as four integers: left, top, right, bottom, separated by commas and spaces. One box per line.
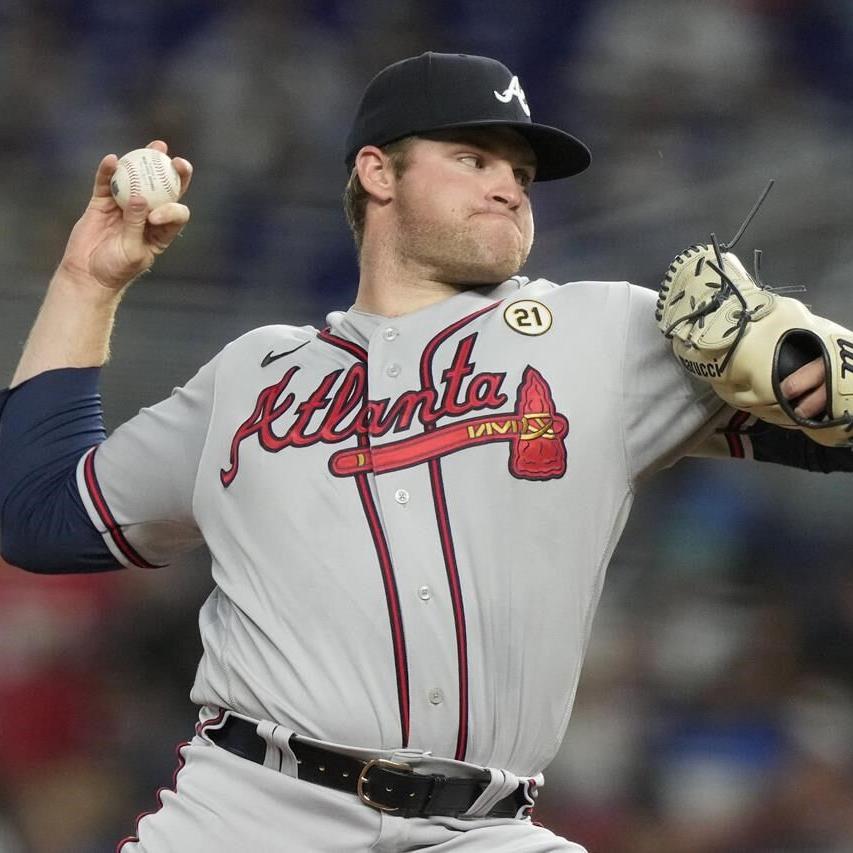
0, 0, 853, 853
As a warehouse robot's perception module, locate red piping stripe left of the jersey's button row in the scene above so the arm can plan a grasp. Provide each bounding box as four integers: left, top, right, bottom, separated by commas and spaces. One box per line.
317, 329, 410, 748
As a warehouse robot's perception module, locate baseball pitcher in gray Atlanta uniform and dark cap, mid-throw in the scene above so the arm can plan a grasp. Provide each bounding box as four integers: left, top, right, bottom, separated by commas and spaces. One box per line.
0, 53, 851, 853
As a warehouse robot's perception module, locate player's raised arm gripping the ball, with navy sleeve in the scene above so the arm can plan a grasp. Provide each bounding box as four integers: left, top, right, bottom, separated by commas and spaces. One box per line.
0, 142, 192, 572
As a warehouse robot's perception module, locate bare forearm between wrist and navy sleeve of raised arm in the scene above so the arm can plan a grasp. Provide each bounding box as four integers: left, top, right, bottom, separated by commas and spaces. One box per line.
10, 266, 124, 388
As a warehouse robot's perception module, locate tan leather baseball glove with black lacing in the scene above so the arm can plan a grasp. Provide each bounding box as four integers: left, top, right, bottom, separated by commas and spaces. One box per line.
655, 245, 853, 447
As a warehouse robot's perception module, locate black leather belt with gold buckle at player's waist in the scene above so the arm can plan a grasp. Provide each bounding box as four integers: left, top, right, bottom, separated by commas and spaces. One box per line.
204, 716, 535, 818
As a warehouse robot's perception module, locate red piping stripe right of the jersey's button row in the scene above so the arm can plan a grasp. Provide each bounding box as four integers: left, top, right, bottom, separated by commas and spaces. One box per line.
420, 302, 500, 761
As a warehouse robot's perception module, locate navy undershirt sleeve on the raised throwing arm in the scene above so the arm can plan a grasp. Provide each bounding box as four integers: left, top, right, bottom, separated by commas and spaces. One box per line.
0, 367, 122, 574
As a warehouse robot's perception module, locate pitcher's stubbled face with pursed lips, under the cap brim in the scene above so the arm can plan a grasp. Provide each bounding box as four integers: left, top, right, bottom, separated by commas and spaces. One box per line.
394, 128, 536, 285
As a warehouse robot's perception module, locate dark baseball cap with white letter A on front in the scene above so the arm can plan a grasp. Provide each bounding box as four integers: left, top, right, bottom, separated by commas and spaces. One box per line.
345, 53, 590, 181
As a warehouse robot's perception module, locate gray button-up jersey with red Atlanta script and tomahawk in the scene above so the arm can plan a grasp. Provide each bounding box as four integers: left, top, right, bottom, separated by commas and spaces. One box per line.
78, 278, 722, 775
